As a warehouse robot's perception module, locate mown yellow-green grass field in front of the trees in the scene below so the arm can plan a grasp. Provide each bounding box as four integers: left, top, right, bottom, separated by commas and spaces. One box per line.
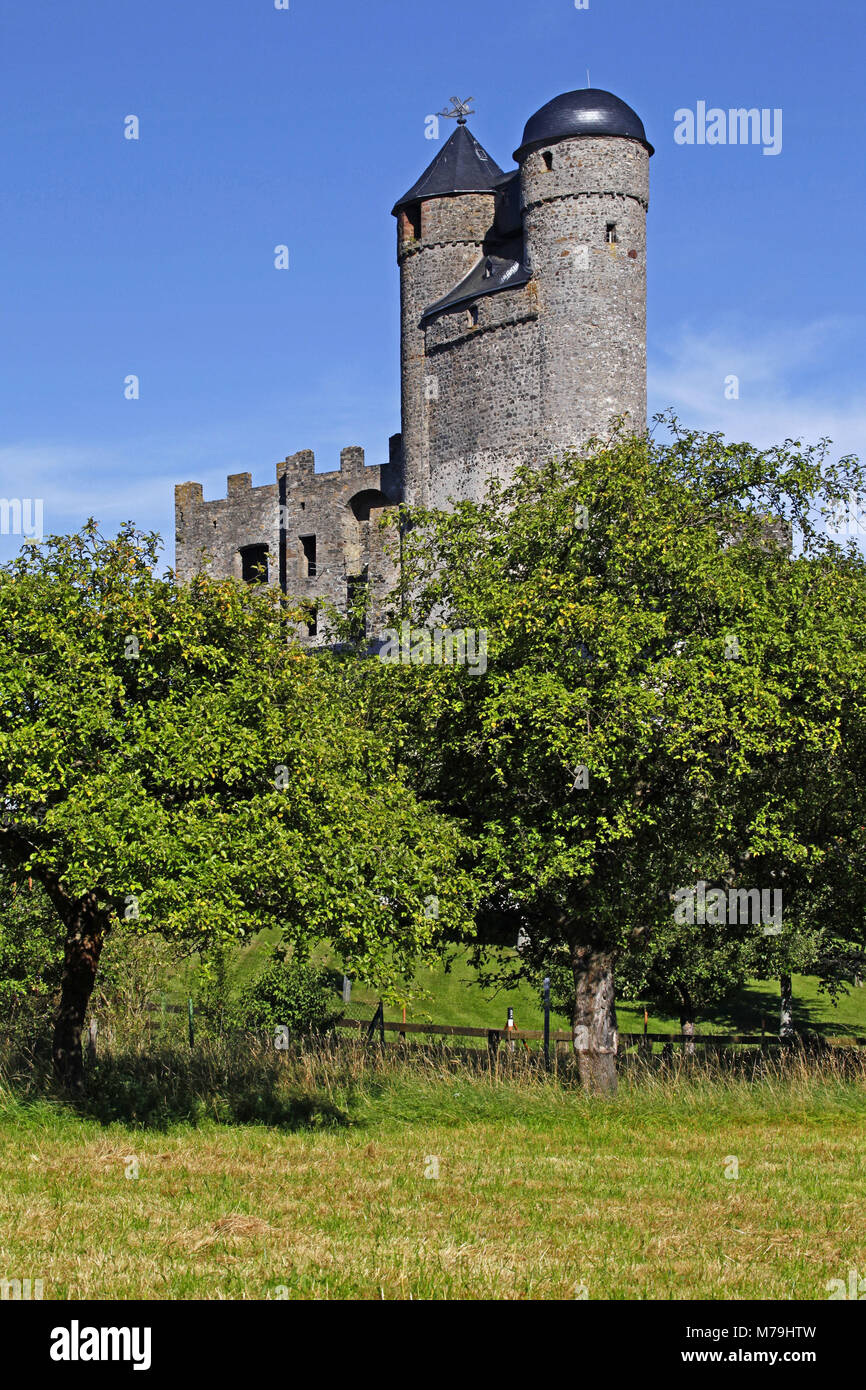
0, 1049, 866, 1300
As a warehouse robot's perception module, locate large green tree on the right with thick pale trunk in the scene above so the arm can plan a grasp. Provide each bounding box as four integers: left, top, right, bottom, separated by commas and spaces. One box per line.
379, 420, 866, 1090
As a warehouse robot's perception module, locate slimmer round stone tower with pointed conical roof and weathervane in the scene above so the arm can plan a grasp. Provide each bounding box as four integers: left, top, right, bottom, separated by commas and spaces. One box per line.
393, 118, 503, 506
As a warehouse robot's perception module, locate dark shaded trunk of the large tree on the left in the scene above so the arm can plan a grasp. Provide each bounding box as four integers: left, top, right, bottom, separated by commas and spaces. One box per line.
51, 892, 107, 1090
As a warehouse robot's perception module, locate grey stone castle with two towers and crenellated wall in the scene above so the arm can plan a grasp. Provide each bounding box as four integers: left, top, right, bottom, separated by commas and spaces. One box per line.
175, 88, 653, 641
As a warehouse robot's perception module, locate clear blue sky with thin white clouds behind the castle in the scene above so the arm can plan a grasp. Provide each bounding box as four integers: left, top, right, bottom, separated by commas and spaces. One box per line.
0, 0, 866, 562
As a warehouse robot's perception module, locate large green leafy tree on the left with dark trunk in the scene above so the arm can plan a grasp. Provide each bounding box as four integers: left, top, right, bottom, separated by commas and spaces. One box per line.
0, 523, 467, 1084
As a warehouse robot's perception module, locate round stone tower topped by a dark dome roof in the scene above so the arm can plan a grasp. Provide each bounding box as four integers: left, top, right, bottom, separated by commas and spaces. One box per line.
514, 88, 653, 453
